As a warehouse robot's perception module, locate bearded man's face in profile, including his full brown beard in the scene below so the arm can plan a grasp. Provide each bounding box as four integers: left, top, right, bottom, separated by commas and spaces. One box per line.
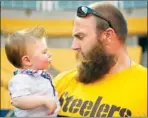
72, 16, 115, 83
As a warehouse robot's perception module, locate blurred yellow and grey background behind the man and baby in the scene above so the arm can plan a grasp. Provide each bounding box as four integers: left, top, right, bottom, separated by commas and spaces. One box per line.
0, 0, 148, 117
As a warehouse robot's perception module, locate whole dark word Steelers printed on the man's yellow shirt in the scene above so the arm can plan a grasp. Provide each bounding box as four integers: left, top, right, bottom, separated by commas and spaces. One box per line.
60, 92, 132, 117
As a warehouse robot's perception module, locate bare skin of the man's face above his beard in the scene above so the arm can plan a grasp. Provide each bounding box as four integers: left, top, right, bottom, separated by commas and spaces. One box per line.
72, 17, 97, 54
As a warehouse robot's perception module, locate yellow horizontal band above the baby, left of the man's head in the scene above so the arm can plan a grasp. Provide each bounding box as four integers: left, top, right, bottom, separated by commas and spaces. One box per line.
1, 18, 73, 36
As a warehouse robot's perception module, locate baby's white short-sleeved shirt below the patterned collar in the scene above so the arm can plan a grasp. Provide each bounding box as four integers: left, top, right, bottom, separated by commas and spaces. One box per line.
9, 74, 60, 117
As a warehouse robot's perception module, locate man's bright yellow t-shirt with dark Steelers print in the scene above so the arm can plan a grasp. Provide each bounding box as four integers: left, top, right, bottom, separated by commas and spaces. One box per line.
54, 64, 147, 117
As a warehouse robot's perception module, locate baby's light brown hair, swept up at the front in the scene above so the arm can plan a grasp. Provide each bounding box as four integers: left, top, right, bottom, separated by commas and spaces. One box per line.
5, 27, 45, 68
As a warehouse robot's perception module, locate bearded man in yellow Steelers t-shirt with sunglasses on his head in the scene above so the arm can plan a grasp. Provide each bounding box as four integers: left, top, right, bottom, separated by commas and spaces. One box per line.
54, 2, 147, 117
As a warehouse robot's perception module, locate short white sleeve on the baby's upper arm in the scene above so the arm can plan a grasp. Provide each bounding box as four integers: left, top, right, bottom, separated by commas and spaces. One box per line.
9, 74, 31, 98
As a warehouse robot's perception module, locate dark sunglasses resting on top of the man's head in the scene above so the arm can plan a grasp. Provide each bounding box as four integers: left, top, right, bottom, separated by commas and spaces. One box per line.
77, 6, 113, 28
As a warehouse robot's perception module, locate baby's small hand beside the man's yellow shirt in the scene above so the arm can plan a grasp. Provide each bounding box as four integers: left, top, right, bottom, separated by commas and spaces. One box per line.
45, 98, 57, 115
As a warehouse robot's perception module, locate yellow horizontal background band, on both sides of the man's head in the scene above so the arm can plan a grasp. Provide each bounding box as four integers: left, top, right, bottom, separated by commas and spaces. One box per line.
1, 17, 147, 36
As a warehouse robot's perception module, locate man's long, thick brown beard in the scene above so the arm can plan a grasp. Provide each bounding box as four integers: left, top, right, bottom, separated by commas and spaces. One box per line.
76, 41, 115, 83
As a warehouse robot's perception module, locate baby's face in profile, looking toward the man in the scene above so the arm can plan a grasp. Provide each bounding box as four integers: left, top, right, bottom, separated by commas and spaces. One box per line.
30, 40, 51, 70
